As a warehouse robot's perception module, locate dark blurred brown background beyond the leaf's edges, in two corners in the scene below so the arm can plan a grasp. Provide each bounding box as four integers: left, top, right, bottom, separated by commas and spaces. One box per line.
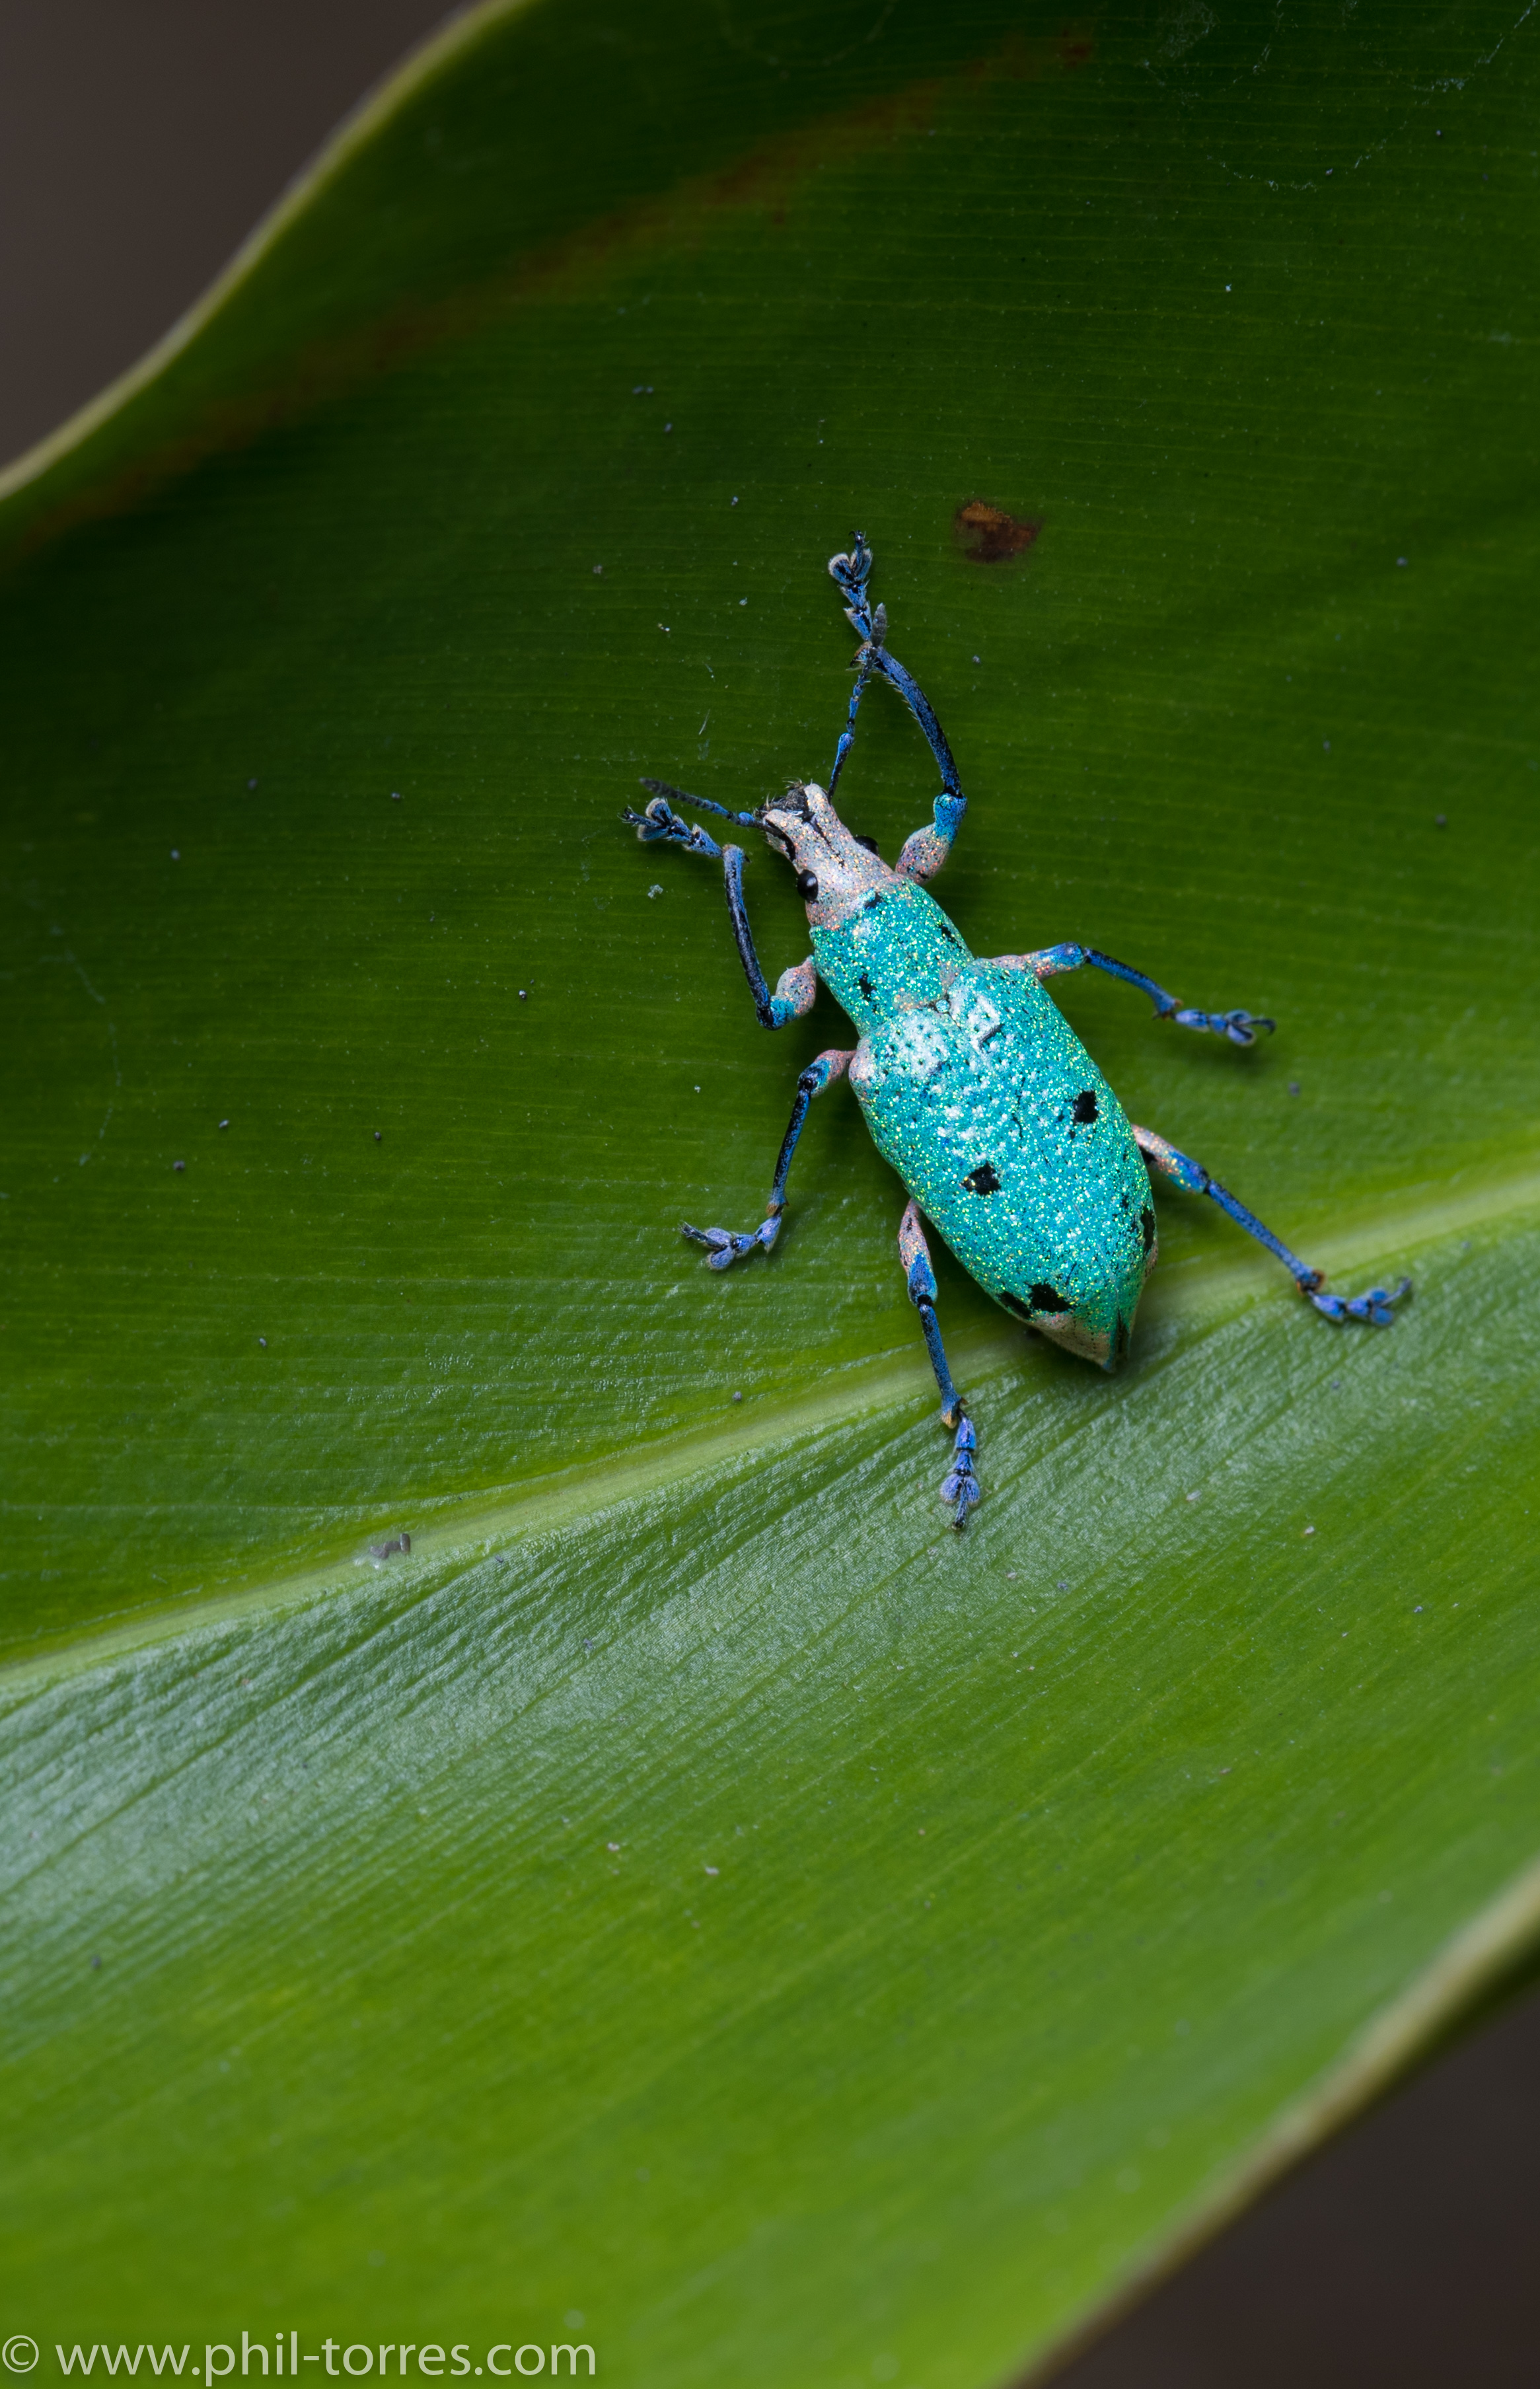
0, 0, 1540, 2389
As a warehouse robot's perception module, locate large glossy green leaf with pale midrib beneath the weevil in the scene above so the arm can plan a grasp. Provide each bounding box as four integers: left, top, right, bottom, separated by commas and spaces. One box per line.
0, 0, 1540, 2389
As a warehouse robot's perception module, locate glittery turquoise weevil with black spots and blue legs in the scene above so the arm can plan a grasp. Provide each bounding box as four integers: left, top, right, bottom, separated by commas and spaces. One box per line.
623, 533, 1411, 1529
